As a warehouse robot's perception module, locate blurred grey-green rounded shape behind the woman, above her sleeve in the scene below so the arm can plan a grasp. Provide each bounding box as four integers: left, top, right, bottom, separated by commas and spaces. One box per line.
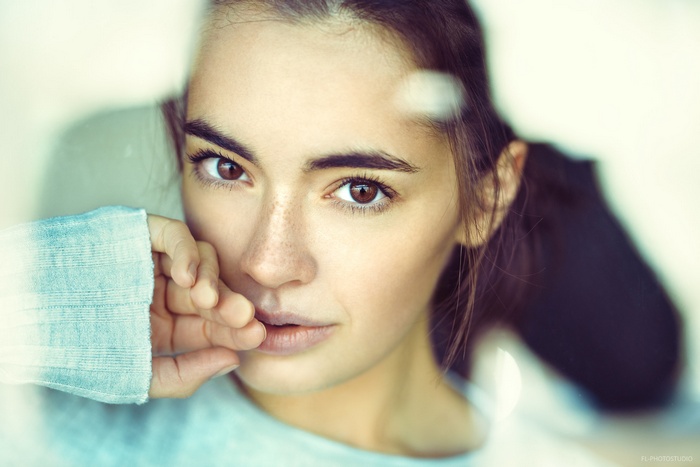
38, 104, 182, 222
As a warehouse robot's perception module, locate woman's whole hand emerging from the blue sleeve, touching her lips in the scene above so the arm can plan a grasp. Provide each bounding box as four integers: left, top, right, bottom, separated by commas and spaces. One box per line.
148, 215, 265, 398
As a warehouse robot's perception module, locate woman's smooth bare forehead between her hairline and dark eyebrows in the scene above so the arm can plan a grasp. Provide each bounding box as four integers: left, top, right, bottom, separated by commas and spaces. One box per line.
188, 12, 448, 157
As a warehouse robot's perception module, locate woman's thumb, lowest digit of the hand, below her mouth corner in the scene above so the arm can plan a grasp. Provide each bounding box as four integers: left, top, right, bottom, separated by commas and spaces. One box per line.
148, 347, 240, 399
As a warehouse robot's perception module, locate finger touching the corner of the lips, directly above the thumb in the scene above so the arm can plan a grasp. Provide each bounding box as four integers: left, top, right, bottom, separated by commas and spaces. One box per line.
172, 316, 266, 353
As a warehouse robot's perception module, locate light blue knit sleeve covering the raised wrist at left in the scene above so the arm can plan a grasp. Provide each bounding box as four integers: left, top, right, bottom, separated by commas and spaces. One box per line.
0, 207, 153, 403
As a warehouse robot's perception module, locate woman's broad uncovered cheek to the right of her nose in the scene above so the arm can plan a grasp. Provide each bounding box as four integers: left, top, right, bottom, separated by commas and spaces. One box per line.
316, 204, 457, 332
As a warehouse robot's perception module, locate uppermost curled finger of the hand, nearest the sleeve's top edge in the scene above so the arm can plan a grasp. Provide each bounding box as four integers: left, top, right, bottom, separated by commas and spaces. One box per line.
148, 214, 199, 287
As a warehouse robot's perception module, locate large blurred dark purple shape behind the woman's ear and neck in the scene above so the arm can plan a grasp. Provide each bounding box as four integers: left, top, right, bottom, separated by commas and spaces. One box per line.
434, 144, 681, 411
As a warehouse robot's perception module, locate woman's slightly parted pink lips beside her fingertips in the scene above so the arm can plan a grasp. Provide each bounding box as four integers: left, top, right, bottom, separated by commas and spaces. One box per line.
255, 308, 335, 356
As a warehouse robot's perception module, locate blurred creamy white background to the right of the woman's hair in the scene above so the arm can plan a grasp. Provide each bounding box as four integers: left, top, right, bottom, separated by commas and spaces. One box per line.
472, 0, 700, 400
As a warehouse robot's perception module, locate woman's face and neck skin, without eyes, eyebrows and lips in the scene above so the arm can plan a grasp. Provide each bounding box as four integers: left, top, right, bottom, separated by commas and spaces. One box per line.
183, 13, 500, 456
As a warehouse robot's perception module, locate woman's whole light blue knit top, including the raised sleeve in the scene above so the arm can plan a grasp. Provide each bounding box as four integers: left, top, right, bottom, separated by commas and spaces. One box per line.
0, 208, 602, 466
